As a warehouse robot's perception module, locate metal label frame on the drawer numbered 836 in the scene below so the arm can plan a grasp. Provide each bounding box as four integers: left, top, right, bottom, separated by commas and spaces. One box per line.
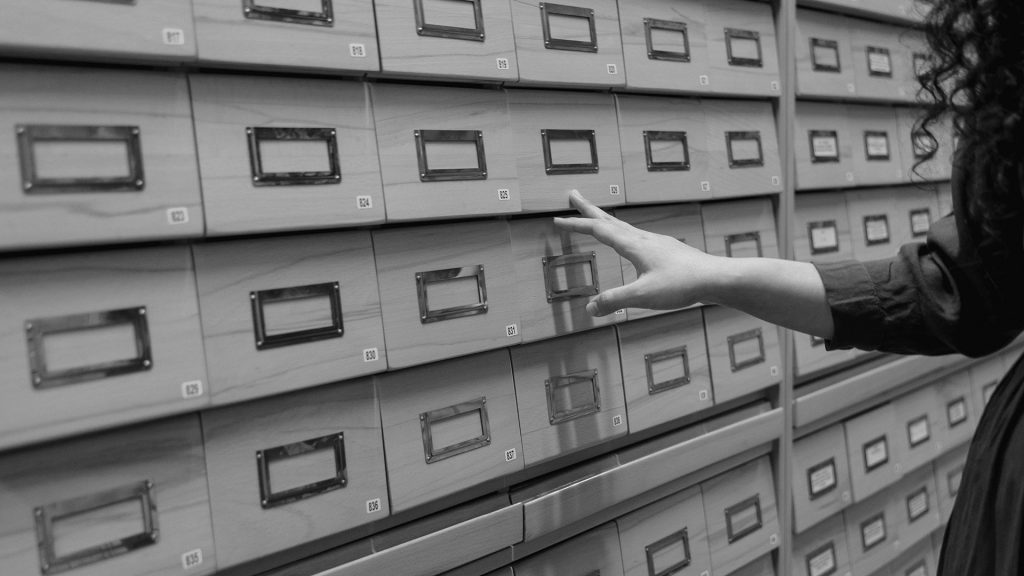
256, 433, 348, 509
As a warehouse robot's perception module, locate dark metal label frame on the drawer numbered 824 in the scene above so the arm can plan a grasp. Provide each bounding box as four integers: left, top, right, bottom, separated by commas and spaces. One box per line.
246, 127, 341, 187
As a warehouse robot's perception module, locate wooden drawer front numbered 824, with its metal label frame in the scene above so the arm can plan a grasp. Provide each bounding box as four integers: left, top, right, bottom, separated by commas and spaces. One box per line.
189, 75, 384, 236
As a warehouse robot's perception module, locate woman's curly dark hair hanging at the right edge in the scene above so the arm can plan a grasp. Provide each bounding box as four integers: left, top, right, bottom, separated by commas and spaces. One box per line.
915, 0, 1024, 250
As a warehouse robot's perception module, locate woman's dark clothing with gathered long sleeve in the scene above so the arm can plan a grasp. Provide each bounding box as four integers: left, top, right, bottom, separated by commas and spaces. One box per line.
817, 155, 1024, 576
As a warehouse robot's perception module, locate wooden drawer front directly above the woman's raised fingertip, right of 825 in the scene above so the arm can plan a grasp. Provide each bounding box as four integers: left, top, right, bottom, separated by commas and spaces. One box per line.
508, 90, 626, 212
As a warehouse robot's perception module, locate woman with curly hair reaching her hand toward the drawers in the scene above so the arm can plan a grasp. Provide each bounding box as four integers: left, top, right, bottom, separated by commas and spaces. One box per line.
556, 0, 1024, 576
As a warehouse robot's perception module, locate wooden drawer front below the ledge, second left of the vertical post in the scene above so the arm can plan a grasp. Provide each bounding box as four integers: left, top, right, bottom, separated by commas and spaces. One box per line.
615, 486, 711, 576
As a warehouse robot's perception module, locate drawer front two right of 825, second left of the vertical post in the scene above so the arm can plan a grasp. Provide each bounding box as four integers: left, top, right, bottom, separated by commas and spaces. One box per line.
615, 94, 711, 204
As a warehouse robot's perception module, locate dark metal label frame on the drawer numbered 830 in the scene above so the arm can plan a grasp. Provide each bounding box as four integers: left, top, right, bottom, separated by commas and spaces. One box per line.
249, 282, 345, 349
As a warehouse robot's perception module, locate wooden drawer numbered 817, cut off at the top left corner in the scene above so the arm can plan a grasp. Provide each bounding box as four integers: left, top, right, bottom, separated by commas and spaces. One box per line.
0, 0, 196, 62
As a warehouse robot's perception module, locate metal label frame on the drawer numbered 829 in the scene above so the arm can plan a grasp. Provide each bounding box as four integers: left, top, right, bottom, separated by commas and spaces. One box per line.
25, 306, 153, 388
